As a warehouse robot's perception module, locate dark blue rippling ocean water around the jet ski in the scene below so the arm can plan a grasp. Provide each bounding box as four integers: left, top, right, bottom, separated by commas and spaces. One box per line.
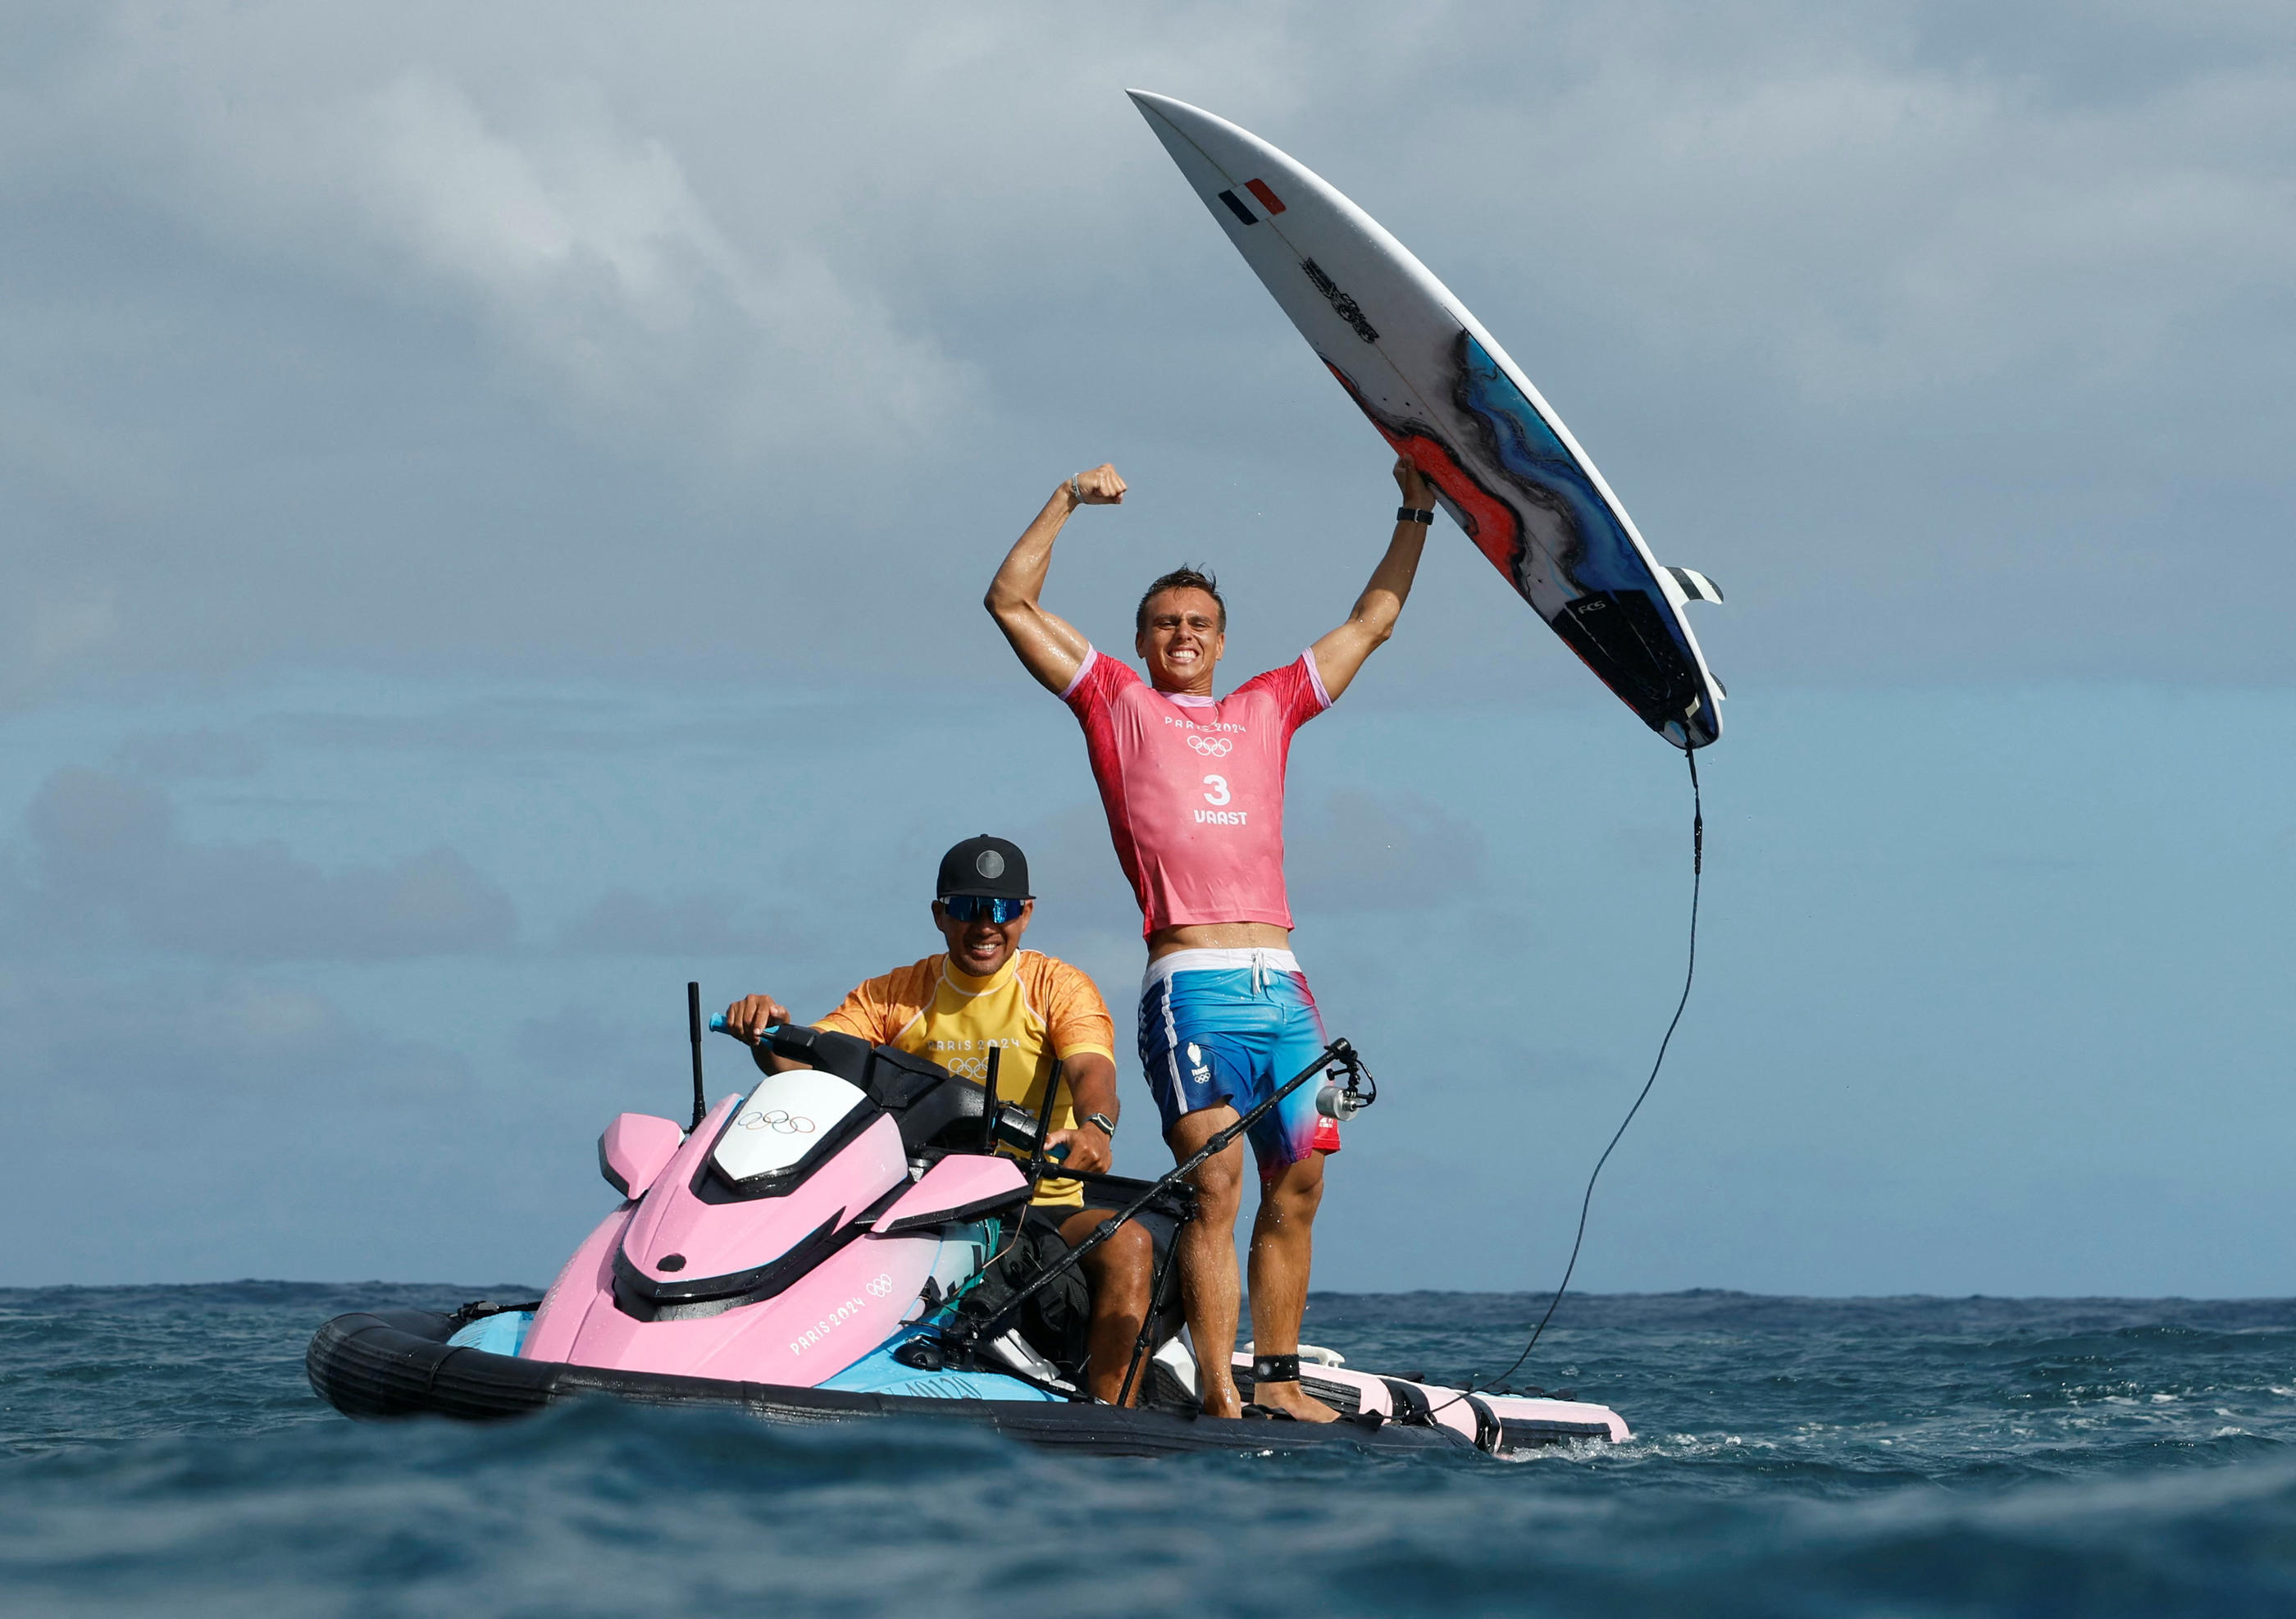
0, 1281, 2296, 1619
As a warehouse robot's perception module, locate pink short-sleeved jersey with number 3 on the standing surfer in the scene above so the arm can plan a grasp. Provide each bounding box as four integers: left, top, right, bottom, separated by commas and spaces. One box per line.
1061, 650, 1332, 933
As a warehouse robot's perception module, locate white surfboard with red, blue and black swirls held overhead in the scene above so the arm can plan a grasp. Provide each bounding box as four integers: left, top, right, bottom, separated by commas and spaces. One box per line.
1128, 89, 1724, 749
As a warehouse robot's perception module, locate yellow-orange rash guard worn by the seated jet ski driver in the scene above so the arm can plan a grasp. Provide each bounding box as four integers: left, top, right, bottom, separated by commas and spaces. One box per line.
815, 951, 1116, 1208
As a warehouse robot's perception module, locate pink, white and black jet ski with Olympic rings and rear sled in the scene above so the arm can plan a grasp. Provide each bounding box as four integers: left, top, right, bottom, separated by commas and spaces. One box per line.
305, 1010, 1628, 1456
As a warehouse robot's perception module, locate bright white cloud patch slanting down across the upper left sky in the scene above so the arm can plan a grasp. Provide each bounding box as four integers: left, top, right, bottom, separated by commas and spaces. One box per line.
314, 66, 967, 459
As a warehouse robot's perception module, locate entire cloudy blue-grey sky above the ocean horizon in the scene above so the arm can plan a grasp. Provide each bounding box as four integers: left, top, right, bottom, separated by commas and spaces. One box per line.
0, 0, 2296, 1295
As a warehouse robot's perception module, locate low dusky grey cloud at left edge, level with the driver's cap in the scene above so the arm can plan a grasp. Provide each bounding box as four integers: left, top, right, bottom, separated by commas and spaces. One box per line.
18, 767, 517, 962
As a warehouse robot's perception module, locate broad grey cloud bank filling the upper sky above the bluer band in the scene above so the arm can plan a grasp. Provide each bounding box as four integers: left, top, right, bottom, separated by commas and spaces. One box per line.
0, 0, 2296, 703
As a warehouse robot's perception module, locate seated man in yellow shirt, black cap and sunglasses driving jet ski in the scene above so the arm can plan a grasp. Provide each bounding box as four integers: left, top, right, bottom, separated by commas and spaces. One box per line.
726, 833, 1155, 1403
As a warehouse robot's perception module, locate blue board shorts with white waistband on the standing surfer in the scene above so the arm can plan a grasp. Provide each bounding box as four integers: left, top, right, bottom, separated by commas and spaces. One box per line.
1141, 951, 1338, 1180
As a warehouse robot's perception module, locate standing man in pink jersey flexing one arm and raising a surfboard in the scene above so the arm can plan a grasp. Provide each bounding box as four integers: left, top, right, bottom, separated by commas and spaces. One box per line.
987, 459, 1435, 1421
